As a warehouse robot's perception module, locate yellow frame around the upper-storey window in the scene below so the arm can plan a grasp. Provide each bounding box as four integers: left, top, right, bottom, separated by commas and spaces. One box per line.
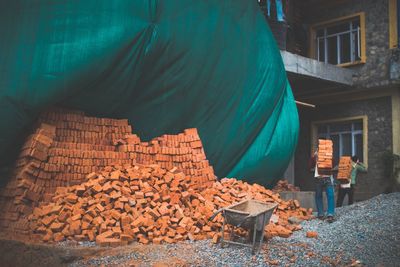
309, 12, 367, 67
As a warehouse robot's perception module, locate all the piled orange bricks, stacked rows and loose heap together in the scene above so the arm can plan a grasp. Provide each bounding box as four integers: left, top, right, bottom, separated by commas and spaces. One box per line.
0, 109, 311, 245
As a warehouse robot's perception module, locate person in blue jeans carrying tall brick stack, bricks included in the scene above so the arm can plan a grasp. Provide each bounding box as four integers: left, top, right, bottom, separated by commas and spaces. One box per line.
310, 140, 335, 223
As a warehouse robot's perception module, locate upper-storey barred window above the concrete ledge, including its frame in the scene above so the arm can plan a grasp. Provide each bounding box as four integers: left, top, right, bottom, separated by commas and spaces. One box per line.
310, 13, 365, 65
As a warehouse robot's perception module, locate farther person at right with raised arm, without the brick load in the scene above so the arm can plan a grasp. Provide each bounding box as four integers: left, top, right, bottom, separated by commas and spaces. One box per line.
337, 155, 367, 207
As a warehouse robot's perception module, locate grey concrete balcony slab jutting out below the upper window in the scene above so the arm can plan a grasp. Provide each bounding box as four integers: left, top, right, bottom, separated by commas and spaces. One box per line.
281, 51, 355, 99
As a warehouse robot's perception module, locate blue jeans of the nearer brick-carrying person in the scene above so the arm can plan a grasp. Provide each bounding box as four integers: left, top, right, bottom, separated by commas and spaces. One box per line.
315, 177, 335, 217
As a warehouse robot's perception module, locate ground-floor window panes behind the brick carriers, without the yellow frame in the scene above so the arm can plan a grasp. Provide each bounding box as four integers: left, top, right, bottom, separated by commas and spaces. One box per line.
316, 120, 364, 166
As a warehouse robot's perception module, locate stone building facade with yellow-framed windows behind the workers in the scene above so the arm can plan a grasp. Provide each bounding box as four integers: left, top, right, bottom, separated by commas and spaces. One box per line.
259, 0, 400, 200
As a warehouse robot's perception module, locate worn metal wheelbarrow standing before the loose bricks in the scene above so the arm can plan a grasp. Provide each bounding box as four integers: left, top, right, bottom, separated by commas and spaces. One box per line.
209, 199, 278, 254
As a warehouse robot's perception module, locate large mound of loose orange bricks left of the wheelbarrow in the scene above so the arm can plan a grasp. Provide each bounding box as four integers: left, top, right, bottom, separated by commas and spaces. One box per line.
29, 164, 214, 246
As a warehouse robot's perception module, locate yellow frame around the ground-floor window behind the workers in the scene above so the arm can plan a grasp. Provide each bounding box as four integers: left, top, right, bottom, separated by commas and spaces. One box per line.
310, 116, 368, 167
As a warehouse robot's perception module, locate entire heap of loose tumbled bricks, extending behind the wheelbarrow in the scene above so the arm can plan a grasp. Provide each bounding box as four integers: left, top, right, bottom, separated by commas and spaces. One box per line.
29, 164, 311, 246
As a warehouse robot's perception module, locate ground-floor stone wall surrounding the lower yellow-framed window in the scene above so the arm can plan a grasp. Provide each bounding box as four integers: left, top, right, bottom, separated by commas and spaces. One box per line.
295, 97, 392, 200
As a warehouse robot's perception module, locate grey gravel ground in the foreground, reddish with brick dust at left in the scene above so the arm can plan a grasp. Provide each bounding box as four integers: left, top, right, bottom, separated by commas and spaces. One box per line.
70, 193, 400, 266
